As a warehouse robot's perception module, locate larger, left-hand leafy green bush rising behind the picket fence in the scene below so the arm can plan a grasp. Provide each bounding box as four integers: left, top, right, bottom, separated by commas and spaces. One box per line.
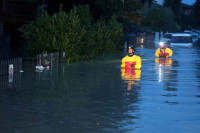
20, 8, 86, 59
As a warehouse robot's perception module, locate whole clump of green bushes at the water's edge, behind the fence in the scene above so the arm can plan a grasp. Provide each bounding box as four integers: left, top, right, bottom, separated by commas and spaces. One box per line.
20, 5, 123, 61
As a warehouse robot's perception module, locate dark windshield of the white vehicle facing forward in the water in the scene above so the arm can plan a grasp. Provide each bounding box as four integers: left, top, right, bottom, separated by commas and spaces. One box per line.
171, 36, 192, 43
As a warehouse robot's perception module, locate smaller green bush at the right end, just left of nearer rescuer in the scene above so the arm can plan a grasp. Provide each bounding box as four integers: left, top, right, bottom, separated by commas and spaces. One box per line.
93, 16, 123, 55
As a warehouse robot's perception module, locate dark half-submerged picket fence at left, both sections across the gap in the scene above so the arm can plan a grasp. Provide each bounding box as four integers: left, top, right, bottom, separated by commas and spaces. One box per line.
0, 52, 65, 88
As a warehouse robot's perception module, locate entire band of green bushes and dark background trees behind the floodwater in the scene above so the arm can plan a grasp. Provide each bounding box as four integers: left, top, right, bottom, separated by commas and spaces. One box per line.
20, 0, 200, 61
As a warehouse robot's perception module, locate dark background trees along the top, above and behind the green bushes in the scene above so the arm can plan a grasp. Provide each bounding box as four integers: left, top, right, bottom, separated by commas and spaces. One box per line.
47, 0, 200, 31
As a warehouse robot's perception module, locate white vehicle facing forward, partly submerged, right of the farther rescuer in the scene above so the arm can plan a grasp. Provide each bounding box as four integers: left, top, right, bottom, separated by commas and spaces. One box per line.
170, 33, 193, 47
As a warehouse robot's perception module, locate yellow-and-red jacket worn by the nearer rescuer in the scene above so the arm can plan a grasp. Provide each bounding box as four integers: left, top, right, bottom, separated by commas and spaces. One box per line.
121, 55, 142, 69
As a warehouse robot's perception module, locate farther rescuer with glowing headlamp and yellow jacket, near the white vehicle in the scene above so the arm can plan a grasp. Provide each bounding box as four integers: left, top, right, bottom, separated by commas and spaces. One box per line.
155, 44, 173, 58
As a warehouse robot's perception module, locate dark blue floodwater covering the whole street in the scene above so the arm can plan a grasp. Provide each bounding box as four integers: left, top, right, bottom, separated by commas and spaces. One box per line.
0, 44, 200, 133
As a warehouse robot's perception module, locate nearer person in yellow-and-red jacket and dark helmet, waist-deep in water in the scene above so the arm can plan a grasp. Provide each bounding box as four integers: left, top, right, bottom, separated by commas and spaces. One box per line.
121, 46, 142, 69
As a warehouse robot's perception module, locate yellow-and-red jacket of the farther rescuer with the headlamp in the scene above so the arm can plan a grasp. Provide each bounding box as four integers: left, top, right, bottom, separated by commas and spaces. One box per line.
155, 48, 173, 57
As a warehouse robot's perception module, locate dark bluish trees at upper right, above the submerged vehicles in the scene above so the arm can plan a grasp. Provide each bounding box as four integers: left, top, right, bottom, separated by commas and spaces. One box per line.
141, 0, 200, 32
